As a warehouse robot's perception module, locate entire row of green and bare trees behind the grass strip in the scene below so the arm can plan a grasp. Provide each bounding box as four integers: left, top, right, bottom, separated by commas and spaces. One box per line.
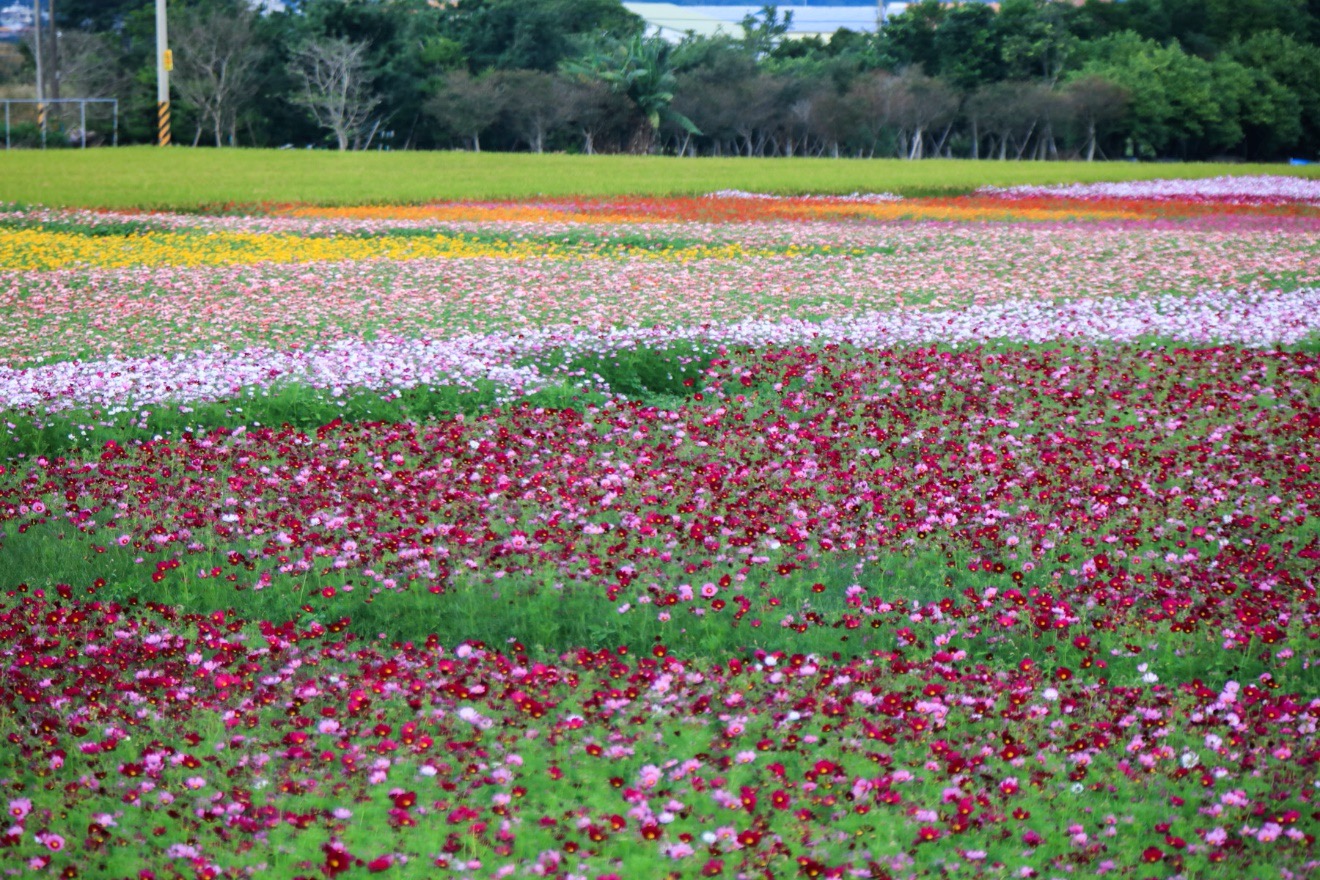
10, 0, 1320, 160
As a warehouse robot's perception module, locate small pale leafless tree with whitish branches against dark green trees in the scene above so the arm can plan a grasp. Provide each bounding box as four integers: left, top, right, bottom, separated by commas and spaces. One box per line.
289, 37, 380, 150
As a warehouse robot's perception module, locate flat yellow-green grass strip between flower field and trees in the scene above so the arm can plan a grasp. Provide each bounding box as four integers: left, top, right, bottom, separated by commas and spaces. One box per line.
0, 146, 1320, 210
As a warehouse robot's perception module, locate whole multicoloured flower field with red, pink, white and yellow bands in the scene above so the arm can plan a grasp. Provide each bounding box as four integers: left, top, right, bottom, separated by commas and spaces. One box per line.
0, 178, 1320, 880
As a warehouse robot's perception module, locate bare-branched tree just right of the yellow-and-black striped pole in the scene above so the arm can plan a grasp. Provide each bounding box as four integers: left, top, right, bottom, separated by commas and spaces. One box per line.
170, 3, 265, 146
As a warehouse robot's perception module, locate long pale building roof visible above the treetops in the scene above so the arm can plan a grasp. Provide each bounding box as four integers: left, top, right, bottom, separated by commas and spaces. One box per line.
623, 1, 907, 42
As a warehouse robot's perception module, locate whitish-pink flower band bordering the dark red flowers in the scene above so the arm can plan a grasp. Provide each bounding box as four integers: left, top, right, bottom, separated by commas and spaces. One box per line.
0, 288, 1320, 416
